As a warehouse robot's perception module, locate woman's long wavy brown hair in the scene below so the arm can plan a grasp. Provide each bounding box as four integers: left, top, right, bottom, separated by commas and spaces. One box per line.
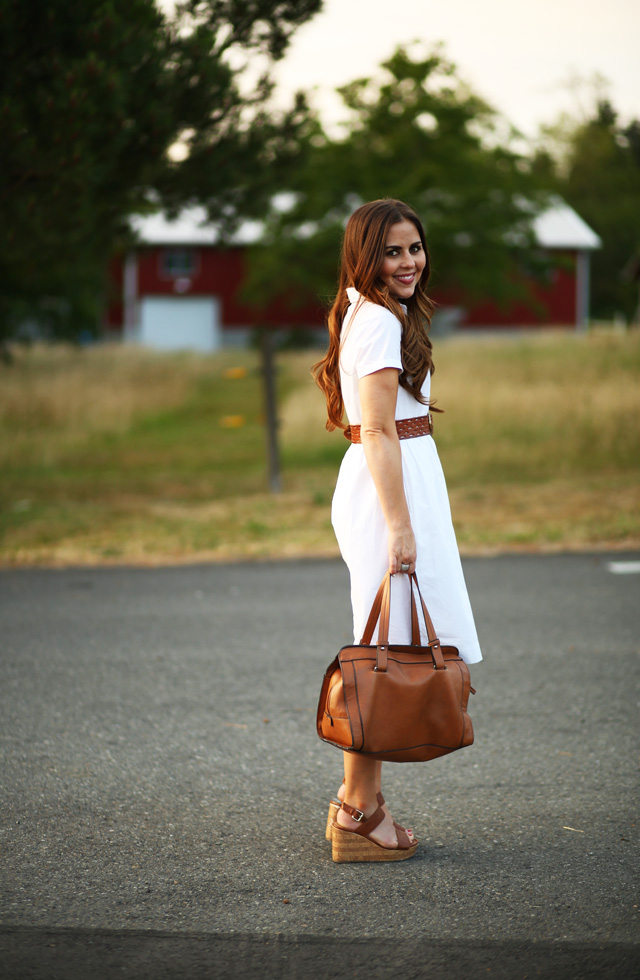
312, 198, 435, 431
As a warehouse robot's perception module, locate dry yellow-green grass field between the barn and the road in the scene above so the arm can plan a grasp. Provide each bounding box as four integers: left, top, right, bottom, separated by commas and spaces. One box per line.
0, 332, 640, 565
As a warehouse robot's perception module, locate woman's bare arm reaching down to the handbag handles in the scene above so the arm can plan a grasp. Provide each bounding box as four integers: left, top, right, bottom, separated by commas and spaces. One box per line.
358, 368, 416, 574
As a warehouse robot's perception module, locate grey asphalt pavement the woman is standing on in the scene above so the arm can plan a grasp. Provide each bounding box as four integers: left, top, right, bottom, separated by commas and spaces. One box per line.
0, 554, 640, 980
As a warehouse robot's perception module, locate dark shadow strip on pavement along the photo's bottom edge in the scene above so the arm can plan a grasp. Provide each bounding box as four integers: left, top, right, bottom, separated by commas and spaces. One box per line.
0, 927, 638, 980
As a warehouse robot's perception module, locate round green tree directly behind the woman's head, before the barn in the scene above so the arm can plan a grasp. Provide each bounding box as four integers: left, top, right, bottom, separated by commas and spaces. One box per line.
247, 48, 548, 316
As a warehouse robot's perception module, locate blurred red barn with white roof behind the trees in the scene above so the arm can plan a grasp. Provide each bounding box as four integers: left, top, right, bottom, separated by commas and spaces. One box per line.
107, 201, 600, 351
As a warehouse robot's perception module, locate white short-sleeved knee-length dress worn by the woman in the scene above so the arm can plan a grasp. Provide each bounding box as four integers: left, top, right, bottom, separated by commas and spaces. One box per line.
331, 288, 482, 663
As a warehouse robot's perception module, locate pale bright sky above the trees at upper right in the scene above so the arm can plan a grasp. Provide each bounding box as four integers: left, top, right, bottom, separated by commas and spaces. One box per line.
268, 0, 640, 136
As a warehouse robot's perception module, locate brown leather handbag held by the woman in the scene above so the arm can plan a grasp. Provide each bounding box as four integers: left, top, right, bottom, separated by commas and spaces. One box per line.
317, 572, 475, 762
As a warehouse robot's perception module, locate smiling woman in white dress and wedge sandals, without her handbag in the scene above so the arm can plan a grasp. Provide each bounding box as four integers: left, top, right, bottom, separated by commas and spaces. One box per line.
314, 199, 482, 861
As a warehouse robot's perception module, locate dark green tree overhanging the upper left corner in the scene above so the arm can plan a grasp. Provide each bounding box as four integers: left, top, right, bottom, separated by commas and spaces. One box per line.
0, 0, 321, 341
